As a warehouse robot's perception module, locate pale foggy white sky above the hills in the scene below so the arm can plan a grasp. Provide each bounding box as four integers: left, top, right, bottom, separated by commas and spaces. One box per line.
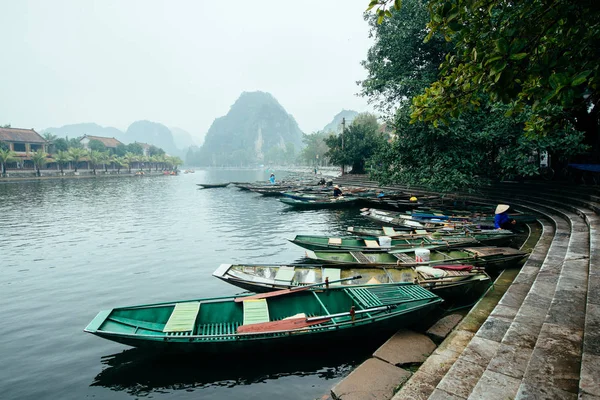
0, 0, 372, 141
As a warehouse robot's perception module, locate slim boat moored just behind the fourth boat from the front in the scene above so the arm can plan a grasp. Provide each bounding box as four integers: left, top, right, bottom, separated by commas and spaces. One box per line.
348, 226, 516, 246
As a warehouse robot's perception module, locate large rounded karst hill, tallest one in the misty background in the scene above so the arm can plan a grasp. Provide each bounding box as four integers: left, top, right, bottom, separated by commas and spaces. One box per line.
191, 92, 303, 166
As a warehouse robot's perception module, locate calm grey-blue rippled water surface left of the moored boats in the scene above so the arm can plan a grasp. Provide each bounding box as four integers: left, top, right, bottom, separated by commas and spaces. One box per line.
0, 170, 376, 400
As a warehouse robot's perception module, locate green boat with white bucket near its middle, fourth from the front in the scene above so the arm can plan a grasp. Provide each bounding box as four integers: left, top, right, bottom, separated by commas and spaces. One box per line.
288, 235, 479, 252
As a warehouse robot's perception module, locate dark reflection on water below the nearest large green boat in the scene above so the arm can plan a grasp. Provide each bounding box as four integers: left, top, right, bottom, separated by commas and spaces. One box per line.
90, 343, 370, 399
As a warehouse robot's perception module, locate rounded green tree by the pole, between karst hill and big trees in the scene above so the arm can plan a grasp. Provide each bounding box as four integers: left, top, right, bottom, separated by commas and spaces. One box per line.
325, 115, 385, 174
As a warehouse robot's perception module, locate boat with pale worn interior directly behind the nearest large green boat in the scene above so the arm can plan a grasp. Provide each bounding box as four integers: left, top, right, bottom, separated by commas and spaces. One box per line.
213, 264, 491, 300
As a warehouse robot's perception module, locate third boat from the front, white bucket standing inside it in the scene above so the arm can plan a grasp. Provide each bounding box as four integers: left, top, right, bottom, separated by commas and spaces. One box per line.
306, 246, 528, 271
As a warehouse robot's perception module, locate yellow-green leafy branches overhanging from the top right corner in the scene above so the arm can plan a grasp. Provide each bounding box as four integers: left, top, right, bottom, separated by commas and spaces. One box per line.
372, 0, 600, 145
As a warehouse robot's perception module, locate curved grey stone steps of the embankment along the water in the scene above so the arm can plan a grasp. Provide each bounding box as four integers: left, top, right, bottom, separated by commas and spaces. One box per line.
332, 176, 600, 400
